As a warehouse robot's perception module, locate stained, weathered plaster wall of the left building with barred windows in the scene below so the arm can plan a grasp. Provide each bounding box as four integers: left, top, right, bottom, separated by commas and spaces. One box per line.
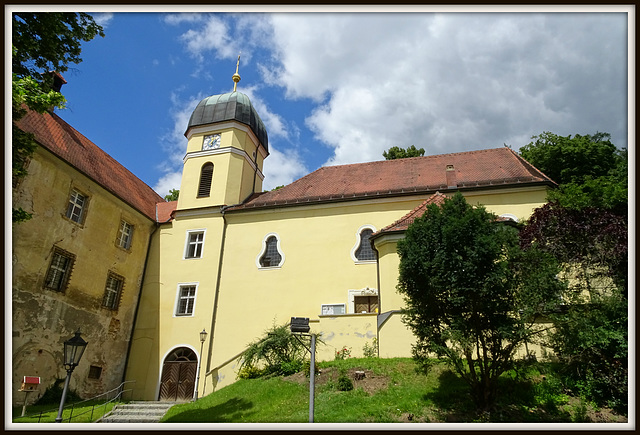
11, 148, 155, 403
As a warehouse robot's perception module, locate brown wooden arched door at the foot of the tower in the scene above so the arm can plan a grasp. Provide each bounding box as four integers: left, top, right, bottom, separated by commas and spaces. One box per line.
158, 347, 198, 402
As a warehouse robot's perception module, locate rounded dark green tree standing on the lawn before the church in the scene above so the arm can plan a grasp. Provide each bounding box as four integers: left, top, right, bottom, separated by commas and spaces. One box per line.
398, 193, 563, 410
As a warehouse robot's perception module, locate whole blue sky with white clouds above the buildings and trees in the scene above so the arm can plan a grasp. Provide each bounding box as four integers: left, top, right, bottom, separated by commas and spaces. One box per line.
13, 8, 635, 195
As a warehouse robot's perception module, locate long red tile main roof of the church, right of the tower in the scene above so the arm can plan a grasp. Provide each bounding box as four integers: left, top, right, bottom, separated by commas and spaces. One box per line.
229, 147, 555, 211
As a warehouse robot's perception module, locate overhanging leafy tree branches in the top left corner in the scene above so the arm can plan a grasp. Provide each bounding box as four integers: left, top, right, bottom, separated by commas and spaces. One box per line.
11, 12, 104, 222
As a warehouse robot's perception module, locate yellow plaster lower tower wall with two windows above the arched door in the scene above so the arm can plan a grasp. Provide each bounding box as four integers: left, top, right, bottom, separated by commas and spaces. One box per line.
127, 213, 223, 400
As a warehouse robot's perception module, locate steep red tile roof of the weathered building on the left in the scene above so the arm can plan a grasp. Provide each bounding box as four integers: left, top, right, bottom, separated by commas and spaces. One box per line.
16, 111, 164, 221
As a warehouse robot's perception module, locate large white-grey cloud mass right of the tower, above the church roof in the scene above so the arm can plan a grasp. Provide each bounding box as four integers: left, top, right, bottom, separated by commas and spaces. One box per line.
263, 13, 627, 164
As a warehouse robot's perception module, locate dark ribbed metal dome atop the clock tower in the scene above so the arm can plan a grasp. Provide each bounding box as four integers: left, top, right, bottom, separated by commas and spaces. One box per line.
187, 92, 269, 152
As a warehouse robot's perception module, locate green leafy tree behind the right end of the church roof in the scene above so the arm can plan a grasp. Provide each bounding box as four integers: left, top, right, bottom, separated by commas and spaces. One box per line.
520, 132, 628, 214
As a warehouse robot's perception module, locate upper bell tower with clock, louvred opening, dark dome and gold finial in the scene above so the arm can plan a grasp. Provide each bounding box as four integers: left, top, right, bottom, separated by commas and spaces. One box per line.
178, 56, 269, 209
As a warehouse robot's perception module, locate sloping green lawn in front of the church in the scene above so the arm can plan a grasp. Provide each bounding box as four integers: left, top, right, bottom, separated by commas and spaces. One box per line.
162, 358, 618, 423
